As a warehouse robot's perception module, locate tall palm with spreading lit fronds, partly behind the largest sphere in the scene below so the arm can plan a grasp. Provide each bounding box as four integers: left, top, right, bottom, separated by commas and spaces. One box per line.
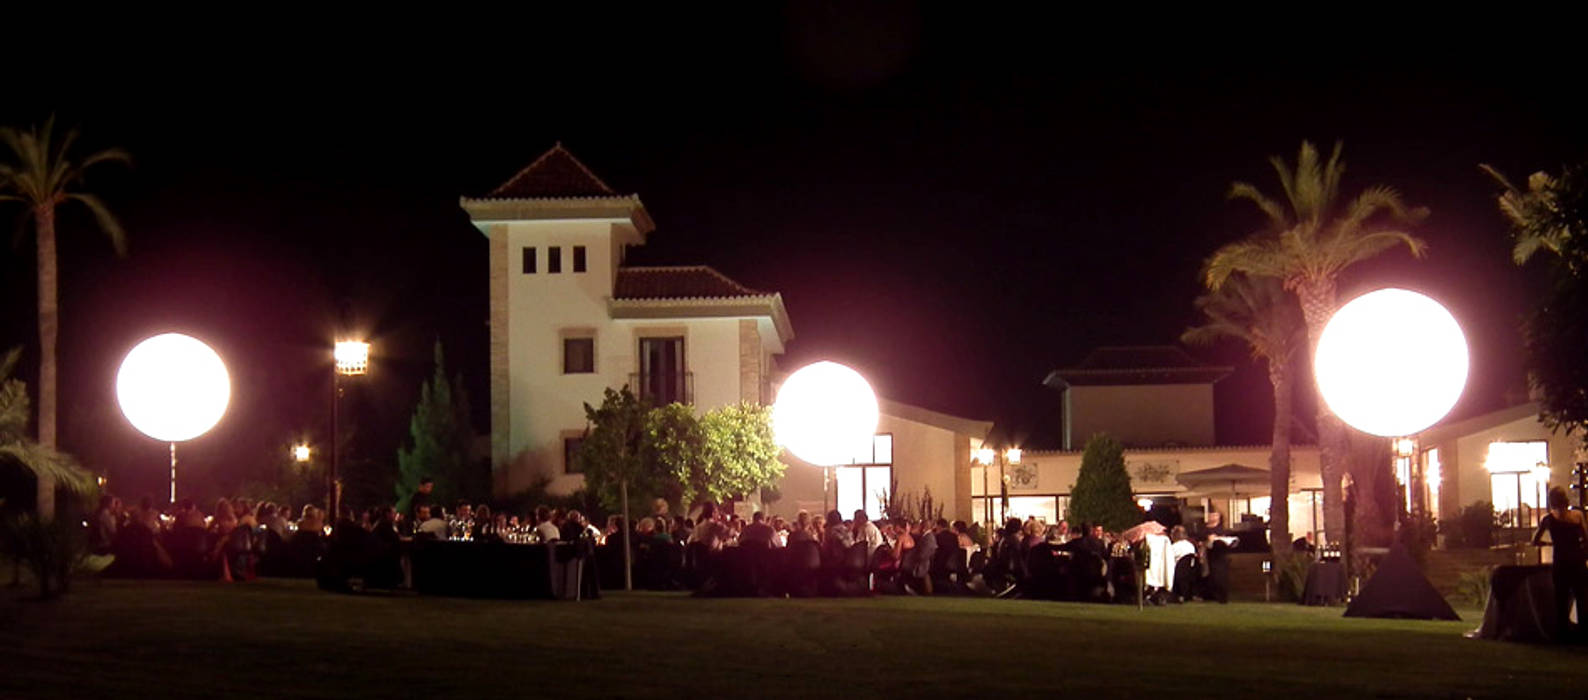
1205, 141, 1428, 541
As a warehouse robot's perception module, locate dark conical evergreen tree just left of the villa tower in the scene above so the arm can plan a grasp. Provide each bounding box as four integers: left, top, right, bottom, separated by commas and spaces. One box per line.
397, 341, 475, 511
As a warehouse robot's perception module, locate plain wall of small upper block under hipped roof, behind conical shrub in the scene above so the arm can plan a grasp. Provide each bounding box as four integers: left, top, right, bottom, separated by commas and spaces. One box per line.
1064, 384, 1213, 449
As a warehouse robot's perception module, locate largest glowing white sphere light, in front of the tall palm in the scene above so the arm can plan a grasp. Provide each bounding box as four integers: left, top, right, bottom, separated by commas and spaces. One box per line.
1315, 289, 1467, 437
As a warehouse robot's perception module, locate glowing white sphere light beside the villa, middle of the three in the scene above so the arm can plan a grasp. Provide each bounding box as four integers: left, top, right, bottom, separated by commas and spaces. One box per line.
772, 362, 877, 467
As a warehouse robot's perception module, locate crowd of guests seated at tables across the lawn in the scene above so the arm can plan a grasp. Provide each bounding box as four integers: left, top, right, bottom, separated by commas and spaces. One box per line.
91, 479, 1234, 603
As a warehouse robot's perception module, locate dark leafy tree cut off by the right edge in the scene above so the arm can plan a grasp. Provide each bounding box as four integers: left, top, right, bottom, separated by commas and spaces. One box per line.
1482, 165, 1588, 435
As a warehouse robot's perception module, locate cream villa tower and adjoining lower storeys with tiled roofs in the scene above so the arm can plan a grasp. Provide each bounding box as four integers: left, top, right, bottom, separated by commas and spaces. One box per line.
461, 143, 794, 495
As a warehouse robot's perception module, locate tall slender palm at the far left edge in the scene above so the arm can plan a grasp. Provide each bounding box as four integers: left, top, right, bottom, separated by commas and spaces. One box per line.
0, 117, 130, 517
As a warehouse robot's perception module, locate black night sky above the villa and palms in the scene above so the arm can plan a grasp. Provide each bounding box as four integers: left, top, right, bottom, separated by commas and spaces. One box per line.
0, 5, 1588, 494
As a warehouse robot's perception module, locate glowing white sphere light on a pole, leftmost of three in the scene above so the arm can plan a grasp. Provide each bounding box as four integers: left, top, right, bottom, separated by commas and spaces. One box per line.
116, 333, 232, 443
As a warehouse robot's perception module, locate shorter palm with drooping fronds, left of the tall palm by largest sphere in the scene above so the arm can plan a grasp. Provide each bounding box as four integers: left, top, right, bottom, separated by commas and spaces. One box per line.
1180, 275, 1305, 562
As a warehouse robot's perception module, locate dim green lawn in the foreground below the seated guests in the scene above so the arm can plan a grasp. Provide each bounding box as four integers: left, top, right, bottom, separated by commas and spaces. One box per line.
0, 581, 1588, 700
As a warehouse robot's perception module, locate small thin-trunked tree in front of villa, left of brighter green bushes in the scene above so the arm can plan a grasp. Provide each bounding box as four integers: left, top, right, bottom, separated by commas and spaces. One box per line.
575, 386, 659, 590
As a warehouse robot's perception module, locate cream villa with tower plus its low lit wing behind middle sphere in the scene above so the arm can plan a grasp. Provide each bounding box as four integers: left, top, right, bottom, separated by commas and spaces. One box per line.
461, 144, 991, 517
